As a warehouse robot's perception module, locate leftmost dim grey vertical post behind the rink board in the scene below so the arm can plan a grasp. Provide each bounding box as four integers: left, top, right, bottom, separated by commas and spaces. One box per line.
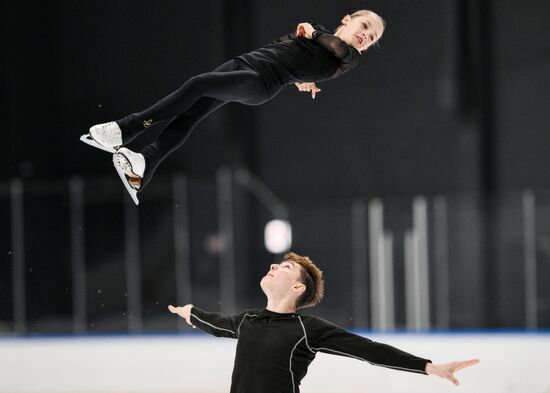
10, 179, 27, 333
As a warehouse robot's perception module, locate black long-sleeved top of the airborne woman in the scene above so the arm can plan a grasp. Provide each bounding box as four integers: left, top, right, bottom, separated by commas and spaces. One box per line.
236, 23, 361, 96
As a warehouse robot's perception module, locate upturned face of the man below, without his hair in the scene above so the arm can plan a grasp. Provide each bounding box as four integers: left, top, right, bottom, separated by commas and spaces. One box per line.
260, 261, 303, 297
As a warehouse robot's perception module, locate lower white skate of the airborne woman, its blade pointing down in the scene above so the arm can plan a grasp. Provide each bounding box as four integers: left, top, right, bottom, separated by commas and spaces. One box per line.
113, 147, 145, 205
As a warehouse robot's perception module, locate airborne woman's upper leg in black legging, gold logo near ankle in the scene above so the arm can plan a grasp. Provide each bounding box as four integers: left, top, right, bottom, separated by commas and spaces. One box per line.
117, 60, 269, 144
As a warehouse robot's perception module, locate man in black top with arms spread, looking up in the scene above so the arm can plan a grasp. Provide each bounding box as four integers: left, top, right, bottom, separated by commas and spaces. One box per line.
168, 253, 479, 393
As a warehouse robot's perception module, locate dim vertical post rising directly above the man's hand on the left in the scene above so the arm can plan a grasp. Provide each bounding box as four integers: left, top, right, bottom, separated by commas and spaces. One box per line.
176, 175, 192, 331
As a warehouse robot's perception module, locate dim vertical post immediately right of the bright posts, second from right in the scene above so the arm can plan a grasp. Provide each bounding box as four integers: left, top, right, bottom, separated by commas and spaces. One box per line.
433, 196, 451, 329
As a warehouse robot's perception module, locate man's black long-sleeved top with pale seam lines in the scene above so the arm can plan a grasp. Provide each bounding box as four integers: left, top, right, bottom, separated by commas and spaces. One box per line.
191, 307, 430, 393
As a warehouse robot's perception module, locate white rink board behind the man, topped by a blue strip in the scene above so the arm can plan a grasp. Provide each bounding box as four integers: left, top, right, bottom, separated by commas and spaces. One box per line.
0, 334, 550, 393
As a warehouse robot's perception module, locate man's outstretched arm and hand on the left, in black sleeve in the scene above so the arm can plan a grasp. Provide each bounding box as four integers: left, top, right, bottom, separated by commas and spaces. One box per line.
168, 304, 254, 338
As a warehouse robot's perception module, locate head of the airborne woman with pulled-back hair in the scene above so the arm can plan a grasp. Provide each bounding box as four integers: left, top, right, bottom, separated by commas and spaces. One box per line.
339, 14, 384, 52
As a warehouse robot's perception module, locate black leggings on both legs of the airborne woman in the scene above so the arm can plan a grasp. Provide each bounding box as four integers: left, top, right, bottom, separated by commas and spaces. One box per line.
117, 59, 283, 190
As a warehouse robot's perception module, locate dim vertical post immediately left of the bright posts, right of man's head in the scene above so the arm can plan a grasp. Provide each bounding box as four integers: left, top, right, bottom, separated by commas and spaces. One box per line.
351, 200, 368, 329
